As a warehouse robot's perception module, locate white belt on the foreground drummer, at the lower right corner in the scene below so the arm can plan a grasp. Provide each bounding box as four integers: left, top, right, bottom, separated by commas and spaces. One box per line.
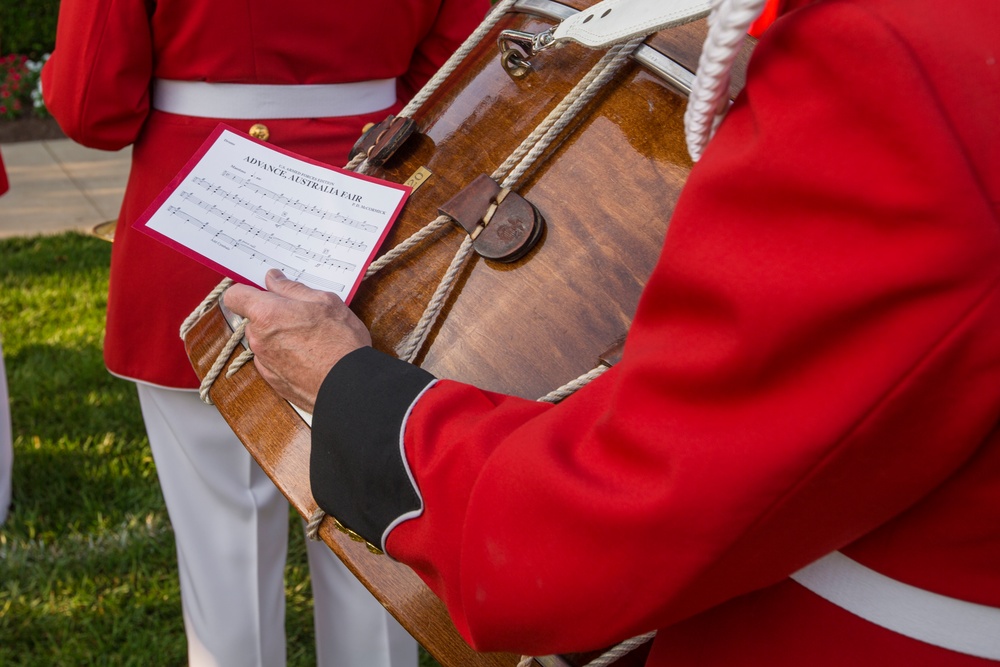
791, 551, 1000, 660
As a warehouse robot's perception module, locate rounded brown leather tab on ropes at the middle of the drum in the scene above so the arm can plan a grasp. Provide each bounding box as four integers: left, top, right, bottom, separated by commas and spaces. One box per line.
438, 174, 545, 262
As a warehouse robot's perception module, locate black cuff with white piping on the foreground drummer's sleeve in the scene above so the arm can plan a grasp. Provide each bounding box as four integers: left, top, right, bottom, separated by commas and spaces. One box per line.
309, 347, 434, 546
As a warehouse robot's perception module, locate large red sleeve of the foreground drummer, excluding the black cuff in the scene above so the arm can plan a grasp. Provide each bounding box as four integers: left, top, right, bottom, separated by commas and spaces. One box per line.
387, 2, 1000, 654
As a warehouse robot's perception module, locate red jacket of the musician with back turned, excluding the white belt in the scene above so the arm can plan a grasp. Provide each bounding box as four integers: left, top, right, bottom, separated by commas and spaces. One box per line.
42, 0, 488, 387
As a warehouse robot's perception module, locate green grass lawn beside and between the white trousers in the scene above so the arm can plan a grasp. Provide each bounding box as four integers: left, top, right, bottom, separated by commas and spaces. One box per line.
0, 233, 437, 667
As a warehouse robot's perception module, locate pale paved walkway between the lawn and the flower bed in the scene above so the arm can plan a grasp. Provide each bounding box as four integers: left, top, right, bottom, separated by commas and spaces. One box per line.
0, 139, 132, 238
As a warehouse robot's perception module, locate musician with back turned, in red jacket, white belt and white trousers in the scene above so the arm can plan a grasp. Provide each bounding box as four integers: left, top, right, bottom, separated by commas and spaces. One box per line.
42, 0, 488, 667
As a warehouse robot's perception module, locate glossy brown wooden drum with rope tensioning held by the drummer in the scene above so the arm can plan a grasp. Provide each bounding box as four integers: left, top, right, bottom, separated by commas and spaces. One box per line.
185, 0, 749, 667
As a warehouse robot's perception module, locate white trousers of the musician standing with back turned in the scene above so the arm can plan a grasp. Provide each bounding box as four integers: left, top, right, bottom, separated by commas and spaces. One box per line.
138, 384, 417, 667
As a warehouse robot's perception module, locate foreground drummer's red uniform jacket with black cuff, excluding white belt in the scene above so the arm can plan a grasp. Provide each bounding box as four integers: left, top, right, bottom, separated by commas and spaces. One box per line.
312, 0, 1000, 667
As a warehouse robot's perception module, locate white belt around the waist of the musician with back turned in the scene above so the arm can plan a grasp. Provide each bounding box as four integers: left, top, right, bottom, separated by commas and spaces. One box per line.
153, 79, 396, 120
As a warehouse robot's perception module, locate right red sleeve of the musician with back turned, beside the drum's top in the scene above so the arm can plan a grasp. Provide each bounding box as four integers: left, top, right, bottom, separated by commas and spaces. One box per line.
399, 0, 490, 100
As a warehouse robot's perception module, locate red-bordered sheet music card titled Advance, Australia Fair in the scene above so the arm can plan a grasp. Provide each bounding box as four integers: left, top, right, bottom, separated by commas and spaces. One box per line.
135, 125, 411, 302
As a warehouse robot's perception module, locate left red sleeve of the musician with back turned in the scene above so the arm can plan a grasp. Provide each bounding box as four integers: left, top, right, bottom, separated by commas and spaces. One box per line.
42, 0, 153, 150
